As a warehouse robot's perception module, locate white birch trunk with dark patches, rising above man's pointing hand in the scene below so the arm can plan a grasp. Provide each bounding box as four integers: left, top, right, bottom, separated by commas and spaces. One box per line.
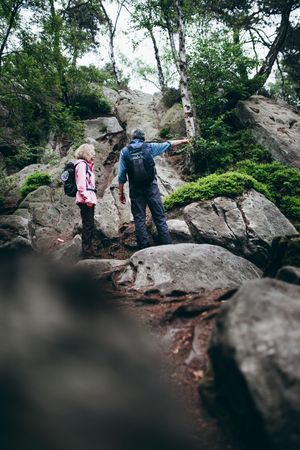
176, 0, 196, 138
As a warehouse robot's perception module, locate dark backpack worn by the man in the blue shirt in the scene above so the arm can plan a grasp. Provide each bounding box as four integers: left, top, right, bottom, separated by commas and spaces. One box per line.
124, 144, 156, 187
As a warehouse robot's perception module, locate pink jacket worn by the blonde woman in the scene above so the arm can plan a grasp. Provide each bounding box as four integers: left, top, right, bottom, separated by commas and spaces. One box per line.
75, 159, 97, 205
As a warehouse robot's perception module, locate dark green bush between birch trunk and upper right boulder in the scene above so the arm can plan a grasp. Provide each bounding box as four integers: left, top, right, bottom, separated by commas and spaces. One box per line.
190, 113, 271, 175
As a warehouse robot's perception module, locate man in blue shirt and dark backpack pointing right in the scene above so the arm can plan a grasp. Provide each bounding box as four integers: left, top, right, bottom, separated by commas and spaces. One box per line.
118, 128, 189, 249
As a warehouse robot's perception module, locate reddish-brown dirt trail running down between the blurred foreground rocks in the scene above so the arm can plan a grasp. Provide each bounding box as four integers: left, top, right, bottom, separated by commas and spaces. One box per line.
115, 290, 245, 450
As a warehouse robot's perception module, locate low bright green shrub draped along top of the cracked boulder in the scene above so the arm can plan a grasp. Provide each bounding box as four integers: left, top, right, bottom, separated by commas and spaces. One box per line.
164, 172, 273, 210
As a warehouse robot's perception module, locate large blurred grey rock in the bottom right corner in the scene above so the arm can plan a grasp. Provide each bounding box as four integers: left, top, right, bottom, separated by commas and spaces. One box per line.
209, 279, 300, 450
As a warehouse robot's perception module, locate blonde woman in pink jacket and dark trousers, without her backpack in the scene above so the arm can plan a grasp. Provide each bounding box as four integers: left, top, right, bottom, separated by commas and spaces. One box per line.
75, 144, 97, 258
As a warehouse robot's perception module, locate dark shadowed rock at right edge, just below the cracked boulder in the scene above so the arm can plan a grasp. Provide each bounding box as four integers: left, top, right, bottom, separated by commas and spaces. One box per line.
264, 234, 300, 277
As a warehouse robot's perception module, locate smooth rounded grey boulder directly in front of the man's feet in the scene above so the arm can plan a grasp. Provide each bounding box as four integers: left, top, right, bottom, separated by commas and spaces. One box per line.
116, 244, 260, 296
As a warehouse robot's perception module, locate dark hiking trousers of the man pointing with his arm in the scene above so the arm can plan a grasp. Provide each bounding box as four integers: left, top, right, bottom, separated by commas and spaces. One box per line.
129, 180, 172, 249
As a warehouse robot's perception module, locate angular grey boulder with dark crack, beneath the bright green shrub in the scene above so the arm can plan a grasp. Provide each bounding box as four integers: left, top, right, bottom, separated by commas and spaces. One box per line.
184, 190, 296, 267
